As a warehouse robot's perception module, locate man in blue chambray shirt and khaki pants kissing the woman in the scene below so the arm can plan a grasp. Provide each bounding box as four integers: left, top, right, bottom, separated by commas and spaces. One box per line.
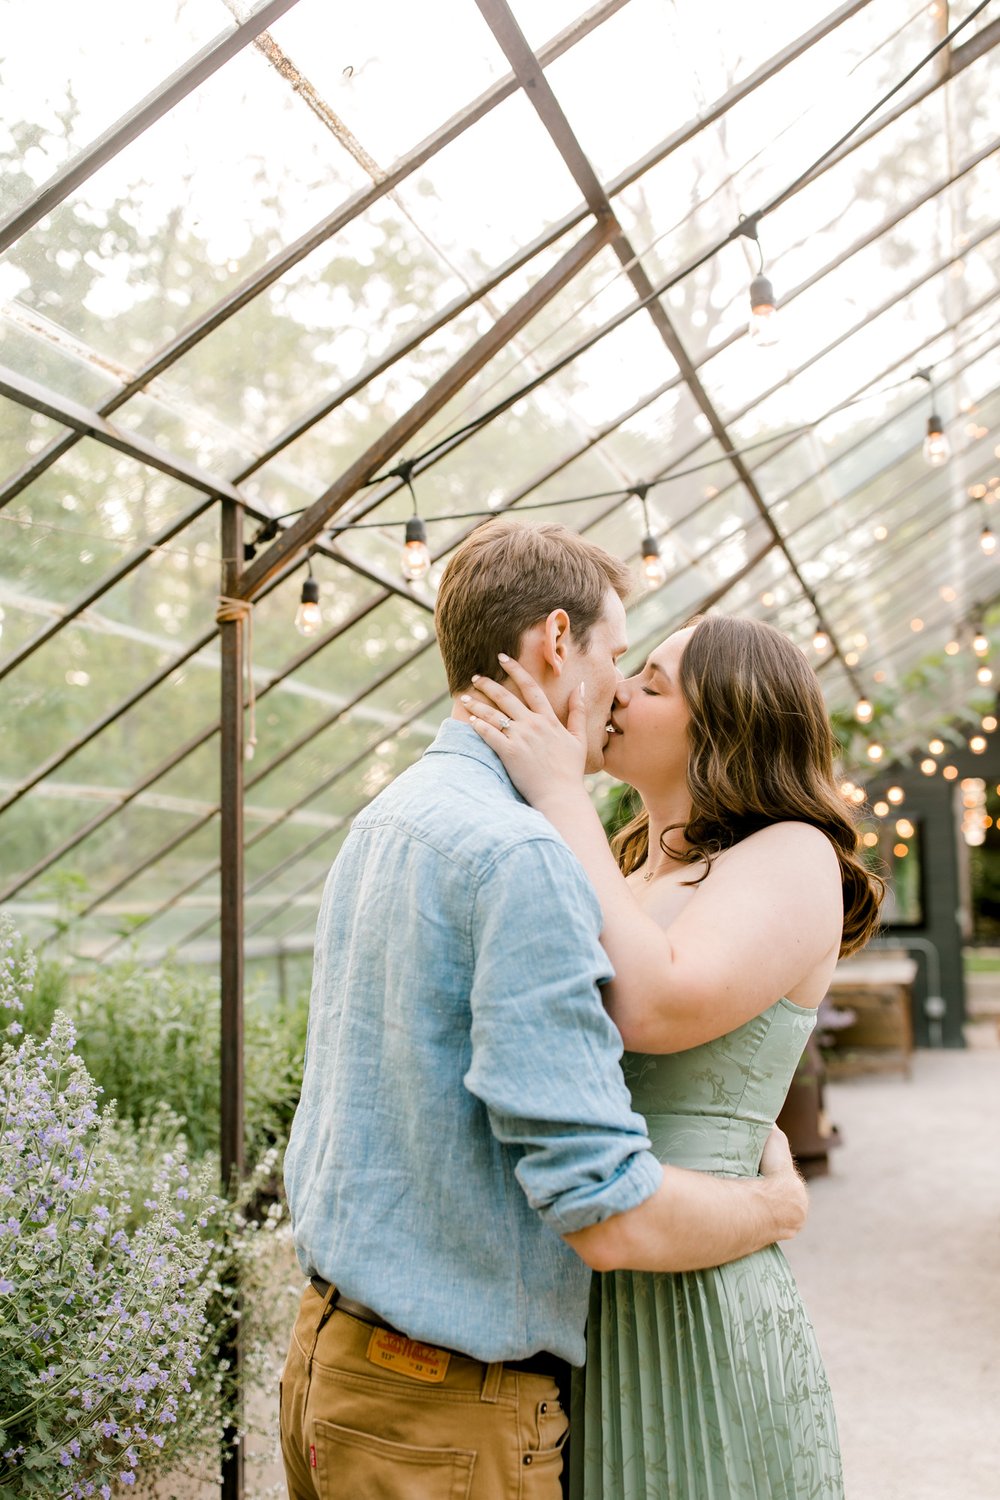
282, 521, 805, 1500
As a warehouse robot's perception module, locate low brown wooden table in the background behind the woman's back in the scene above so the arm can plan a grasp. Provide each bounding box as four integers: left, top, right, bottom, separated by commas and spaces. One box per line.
820, 954, 916, 1079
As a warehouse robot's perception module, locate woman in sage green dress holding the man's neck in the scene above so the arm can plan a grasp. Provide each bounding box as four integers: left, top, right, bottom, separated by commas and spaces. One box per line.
468, 615, 883, 1500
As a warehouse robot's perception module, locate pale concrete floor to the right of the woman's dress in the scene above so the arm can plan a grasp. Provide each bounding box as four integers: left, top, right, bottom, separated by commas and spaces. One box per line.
786, 1044, 1000, 1500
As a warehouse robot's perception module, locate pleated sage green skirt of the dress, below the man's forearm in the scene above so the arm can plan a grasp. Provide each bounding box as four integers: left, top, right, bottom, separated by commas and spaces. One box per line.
570, 1245, 844, 1500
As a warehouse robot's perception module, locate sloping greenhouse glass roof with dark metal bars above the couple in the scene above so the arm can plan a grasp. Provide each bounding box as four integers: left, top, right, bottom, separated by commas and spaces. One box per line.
0, 0, 1000, 959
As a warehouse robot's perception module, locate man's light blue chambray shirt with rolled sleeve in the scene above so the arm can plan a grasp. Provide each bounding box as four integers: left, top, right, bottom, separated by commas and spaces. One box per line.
285, 720, 663, 1365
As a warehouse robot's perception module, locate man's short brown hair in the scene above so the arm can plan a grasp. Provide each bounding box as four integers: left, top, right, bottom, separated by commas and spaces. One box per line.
435, 518, 633, 693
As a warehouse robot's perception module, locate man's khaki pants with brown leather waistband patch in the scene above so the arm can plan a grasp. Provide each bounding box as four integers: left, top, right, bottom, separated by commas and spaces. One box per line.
280, 1287, 570, 1500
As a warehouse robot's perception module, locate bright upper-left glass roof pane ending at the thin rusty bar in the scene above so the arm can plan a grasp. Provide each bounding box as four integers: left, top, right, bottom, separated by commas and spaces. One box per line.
4, 48, 370, 387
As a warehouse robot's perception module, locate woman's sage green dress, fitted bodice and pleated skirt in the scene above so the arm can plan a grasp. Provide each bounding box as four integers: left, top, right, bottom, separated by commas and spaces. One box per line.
570, 999, 844, 1500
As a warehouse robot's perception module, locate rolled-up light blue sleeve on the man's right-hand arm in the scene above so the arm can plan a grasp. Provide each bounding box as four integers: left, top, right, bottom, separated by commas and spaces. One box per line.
463, 836, 663, 1235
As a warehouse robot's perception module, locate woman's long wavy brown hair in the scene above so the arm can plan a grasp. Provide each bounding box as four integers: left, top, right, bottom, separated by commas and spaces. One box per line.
612, 615, 885, 957
